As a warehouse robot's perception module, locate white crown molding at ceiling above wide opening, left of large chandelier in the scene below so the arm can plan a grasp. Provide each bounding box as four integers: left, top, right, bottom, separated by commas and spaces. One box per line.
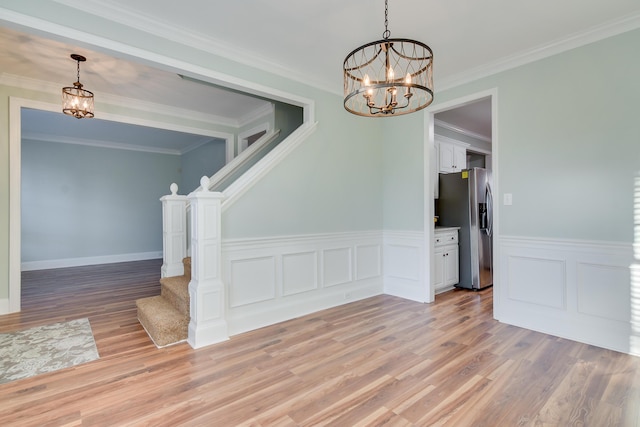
54, 0, 341, 93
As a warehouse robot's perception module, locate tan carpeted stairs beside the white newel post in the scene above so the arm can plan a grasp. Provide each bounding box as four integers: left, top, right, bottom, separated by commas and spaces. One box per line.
136, 258, 191, 347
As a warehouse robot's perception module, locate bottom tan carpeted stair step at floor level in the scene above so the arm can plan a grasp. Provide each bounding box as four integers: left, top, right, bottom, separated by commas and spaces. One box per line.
136, 295, 189, 347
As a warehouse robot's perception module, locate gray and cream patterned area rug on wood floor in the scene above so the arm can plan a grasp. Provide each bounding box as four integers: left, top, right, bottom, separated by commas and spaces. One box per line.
0, 319, 99, 384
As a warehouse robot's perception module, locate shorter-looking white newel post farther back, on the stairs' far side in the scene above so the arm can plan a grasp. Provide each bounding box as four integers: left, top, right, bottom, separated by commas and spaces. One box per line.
160, 183, 187, 277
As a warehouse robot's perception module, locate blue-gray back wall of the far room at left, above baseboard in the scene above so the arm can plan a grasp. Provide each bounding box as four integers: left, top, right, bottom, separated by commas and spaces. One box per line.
22, 140, 180, 262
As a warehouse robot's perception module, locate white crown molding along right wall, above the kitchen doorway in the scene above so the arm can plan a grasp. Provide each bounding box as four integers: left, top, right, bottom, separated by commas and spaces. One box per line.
437, 13, 640, 90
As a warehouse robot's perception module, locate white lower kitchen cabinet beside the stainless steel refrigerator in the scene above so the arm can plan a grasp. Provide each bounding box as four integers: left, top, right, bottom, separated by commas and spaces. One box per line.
433, 227, 460, 292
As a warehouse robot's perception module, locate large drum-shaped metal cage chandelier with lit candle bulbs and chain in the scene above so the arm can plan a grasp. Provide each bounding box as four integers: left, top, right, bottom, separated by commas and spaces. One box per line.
344, 0, 433, 117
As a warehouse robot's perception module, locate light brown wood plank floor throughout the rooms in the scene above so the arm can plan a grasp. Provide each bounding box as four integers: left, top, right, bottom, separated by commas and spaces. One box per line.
0, 261, 640, 427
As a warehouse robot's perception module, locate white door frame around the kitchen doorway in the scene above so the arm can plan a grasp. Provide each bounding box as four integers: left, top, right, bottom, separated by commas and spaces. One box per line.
424, 88, 500, 319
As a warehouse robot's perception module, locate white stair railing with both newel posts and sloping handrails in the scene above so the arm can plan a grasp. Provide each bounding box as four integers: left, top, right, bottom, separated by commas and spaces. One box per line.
160, 123, 316, 348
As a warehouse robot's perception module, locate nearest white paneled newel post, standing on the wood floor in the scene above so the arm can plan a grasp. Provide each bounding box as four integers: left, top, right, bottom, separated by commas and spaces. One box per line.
188, 176, 229, 348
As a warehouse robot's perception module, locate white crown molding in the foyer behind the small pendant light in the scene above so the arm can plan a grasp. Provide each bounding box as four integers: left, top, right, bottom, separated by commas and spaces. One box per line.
0, 73, 240, 128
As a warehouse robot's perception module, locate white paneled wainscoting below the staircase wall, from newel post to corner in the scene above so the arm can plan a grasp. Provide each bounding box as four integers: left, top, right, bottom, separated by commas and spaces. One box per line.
222, 231, 383, 335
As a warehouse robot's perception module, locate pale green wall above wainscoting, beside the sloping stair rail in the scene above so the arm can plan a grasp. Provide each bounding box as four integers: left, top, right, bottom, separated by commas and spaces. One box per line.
222, 89, 383, 238
